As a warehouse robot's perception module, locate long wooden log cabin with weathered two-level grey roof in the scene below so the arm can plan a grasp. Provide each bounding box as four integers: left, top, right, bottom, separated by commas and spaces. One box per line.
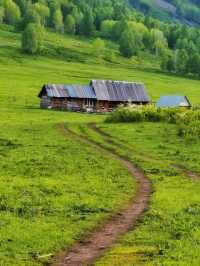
38, 80, 150, 112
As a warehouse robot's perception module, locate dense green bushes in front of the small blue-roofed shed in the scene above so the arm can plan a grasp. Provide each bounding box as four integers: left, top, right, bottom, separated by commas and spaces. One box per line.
106, 105, 200, 140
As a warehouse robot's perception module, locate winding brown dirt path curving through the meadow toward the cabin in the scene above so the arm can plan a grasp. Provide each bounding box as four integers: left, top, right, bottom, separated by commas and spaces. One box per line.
52, 125, 151, 266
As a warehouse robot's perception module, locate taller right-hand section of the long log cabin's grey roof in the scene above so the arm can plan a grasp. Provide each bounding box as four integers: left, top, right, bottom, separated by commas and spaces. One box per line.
90, 80, 150, 102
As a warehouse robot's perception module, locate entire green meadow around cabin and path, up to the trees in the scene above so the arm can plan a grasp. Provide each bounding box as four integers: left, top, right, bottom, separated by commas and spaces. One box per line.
0, 28, 200, 266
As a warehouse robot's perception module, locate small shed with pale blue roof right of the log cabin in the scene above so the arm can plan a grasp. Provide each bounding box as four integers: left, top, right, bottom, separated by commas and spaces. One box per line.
156, 95, 191, 107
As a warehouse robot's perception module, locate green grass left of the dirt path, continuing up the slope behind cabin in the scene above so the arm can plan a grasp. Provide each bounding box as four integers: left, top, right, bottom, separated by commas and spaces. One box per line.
0, 29, 200, 266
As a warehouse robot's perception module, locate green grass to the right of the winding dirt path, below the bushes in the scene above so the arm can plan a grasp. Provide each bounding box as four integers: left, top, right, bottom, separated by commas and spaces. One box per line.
92, 123, 200, 266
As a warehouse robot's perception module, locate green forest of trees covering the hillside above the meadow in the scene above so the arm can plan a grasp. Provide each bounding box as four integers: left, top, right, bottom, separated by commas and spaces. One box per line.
0, 0, 200, 76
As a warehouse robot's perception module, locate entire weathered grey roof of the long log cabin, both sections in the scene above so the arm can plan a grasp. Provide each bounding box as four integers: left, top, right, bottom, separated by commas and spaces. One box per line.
38, 80, 150, 102
